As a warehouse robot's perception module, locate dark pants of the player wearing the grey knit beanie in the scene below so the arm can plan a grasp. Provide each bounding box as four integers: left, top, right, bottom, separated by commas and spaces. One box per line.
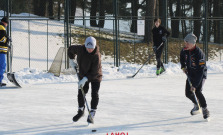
185, 79, 207, 108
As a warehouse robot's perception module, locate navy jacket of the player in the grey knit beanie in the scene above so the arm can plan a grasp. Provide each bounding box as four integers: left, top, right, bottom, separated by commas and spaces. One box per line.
180, 46, 207, 88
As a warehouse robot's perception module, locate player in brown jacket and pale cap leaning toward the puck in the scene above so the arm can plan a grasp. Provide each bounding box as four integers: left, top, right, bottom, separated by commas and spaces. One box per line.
68, 37, 102, 123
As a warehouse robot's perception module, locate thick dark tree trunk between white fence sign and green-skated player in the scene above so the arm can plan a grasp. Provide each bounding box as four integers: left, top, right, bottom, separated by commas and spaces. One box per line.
144, 0, 156, 43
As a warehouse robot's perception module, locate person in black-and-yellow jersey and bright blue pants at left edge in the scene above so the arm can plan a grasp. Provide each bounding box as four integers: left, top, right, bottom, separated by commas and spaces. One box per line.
0, 17, 10, 87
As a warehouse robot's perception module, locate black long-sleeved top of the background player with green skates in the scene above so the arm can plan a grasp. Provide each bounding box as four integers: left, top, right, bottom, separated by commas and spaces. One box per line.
152, 25, 170, 47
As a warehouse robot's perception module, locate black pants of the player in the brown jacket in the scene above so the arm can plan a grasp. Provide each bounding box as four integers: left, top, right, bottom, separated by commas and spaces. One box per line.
77, 82, 100, 109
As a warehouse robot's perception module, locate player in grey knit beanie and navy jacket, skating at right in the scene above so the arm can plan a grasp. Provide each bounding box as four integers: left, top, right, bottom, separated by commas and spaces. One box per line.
180, 34, 210, 119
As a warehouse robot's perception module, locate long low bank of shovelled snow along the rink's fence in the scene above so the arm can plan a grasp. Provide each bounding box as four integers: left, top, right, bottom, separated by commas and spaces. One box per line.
3, 62, 223, 85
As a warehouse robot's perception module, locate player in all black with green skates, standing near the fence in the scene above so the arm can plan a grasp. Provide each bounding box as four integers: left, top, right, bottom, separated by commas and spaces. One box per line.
152, 18, 170, 75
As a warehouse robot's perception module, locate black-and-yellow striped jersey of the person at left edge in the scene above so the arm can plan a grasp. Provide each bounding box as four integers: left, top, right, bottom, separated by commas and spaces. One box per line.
0, 22, 8, 54
